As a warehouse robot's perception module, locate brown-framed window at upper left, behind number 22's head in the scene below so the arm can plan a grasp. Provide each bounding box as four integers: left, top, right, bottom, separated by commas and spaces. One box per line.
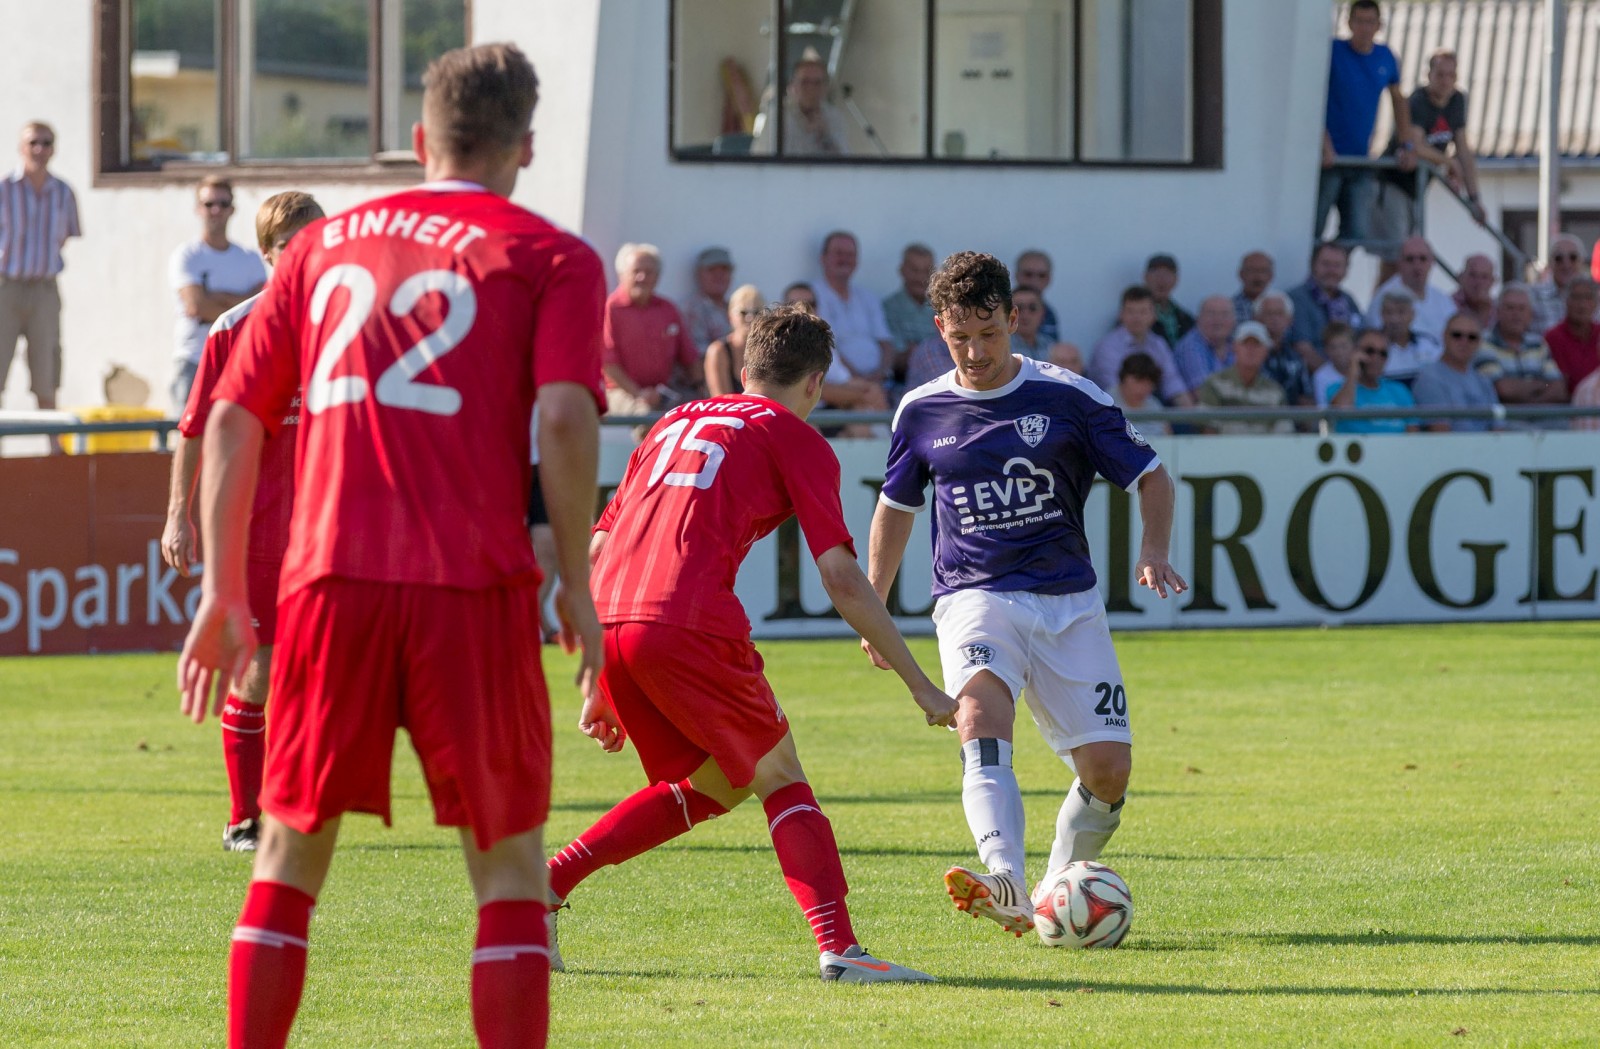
98, 0, 467, 177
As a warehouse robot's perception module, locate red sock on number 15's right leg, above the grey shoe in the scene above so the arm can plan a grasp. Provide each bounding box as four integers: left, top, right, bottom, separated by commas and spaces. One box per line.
763, 782, 856, 953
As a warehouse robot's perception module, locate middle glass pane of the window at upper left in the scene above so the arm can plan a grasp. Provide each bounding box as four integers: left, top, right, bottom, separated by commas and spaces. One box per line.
238, 0, 373, 160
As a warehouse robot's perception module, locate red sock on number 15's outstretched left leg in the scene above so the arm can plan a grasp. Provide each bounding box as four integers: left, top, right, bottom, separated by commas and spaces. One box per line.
550, 780, 728, 900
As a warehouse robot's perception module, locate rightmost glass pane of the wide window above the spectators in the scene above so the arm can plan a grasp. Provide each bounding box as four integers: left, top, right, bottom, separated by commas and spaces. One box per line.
1082, 0, 1194, 162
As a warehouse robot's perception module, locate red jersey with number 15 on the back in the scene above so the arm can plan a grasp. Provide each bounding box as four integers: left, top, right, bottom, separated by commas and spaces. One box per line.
592, 393, 854, 638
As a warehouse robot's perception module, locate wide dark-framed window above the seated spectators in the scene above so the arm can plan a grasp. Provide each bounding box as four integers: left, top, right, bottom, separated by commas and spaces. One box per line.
670, 0, 1222, 166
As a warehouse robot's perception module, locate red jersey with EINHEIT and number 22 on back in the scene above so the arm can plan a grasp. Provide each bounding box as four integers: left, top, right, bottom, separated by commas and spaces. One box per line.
216, 181, 605, 596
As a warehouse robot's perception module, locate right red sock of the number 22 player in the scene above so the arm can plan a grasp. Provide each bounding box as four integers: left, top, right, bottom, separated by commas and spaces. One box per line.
472, 900, 550, 1049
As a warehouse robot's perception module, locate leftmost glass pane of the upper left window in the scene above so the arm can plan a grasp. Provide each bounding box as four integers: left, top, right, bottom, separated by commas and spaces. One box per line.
128, 0, 227, 165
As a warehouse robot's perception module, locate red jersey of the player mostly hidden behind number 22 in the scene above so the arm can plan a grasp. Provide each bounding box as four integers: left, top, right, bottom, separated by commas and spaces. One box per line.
178, 294, 301, 564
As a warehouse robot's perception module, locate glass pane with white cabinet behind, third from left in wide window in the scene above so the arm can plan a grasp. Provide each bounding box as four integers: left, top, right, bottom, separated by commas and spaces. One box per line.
933, 0, 1074, 160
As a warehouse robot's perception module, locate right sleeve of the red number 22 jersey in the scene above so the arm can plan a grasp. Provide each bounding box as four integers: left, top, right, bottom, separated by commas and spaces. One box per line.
533, 241, 610, 414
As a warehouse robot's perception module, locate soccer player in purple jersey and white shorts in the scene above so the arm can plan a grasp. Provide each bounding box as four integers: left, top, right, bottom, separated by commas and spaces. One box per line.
862, 251, 1189, 935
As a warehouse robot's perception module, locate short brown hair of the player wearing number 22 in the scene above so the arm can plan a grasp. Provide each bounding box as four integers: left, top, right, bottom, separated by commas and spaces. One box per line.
422, 43, 539, 160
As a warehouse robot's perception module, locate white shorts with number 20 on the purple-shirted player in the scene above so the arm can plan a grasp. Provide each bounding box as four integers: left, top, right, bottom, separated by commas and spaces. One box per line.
933, 590, 1133, 764
